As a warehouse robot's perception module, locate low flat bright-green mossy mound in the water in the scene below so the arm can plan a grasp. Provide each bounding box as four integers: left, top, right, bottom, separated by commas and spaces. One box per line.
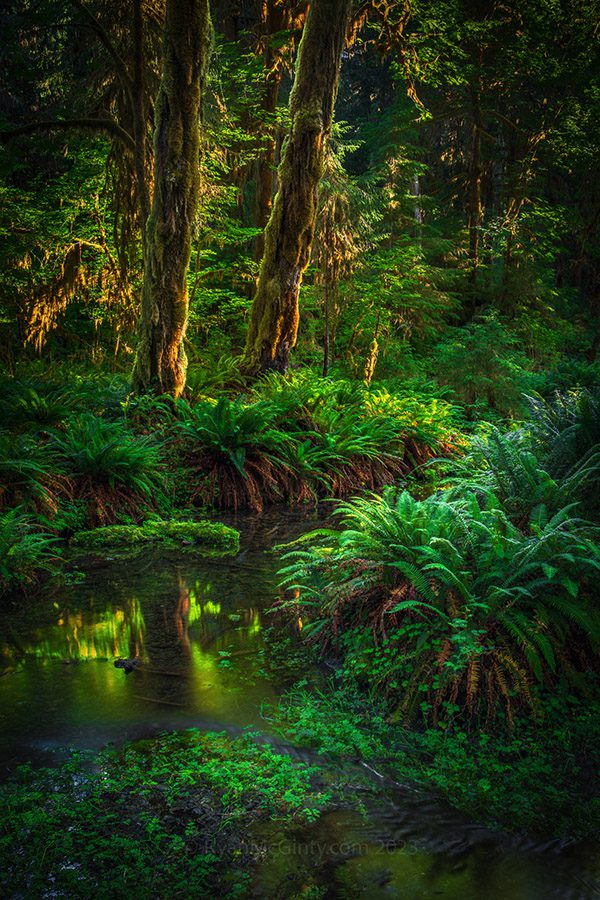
71, 519, 240, 556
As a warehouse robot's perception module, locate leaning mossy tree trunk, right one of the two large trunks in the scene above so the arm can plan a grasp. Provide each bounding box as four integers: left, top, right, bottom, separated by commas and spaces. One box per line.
241, 0, 350, 376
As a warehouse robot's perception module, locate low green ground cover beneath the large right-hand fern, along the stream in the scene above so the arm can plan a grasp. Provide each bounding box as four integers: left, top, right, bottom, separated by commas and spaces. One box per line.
269, 672, 600, 839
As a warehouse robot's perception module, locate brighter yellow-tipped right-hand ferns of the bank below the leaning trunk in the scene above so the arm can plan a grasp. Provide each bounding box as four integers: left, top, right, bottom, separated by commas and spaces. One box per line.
254, 371, 456, 497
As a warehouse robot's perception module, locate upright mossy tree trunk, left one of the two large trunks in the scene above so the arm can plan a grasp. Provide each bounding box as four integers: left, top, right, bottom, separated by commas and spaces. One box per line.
133, 0, 211, 398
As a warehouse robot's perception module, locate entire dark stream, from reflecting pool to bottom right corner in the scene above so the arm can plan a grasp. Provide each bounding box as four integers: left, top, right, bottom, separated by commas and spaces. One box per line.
0, 509, 600, 900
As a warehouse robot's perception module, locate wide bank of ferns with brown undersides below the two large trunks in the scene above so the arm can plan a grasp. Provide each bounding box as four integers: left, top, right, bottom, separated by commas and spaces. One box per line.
173, 373, 456, 511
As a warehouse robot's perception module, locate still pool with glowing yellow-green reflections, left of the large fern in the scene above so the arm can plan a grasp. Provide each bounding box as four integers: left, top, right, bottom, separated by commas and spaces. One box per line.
0, 554, 292, 767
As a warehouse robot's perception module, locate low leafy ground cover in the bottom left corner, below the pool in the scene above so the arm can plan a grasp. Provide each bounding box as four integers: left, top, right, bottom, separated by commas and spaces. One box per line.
0, 731, 327, 898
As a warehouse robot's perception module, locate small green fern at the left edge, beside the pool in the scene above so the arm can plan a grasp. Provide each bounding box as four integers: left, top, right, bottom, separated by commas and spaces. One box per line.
0, 507, 58, 597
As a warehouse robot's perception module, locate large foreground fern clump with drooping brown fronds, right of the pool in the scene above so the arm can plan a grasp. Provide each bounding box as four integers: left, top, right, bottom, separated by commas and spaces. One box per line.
282, 491, 600, 720
